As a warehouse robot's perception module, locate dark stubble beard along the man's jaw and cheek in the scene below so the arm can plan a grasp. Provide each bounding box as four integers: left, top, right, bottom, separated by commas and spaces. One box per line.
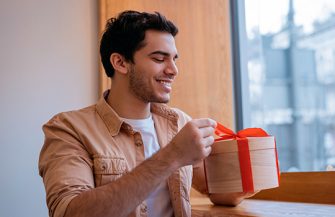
128, 66, 169, 103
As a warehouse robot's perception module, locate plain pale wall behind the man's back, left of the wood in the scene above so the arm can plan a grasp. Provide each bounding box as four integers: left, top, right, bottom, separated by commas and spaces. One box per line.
0, 0, 98, 217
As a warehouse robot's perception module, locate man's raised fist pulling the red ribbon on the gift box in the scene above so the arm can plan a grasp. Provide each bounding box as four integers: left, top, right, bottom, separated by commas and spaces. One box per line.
168, 118, 216, 166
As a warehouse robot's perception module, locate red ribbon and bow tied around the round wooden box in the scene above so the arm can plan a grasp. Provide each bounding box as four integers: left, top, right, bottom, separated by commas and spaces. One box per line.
205, 123, 279, 192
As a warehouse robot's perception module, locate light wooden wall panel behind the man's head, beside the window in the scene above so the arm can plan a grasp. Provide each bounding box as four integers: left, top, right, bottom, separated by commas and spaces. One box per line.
100, 0, 233, 127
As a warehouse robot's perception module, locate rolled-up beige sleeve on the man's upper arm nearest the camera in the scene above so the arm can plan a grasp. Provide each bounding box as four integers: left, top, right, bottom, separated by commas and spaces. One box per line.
39, 114, 94, 217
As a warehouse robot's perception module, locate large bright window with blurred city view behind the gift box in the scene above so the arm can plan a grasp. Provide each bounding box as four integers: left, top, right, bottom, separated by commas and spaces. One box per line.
235, 0, 335, 171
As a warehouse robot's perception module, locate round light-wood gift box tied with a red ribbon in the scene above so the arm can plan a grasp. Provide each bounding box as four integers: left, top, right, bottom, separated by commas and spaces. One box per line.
204, 124, 279, 194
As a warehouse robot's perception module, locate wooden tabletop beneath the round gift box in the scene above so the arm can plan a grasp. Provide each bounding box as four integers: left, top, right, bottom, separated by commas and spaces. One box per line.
191, 197, 335, 217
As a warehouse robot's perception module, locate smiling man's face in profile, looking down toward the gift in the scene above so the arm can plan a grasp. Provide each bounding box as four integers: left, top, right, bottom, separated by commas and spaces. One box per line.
128, 30, 178, 103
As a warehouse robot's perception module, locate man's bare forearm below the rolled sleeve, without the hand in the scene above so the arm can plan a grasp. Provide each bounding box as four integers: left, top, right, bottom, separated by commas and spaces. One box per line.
65, 143, 180, 217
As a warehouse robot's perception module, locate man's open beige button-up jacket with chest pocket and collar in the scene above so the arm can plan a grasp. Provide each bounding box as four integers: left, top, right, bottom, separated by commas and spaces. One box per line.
39, 95, 192, 217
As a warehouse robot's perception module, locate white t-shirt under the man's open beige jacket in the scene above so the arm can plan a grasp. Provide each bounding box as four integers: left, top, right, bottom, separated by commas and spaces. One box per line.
122, 115, 173, 217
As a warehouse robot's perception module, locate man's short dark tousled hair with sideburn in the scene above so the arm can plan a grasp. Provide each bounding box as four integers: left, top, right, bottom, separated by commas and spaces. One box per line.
100, 11, 178, 77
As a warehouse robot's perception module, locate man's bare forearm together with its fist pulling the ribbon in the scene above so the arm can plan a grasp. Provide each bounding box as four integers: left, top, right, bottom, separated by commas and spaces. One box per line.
65, 119, 216, 217
